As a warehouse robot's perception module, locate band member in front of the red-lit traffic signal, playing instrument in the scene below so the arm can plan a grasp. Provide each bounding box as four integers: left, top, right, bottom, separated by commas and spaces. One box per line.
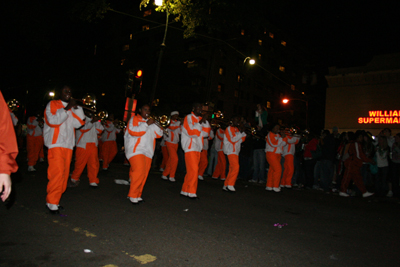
125, 104, 163, 204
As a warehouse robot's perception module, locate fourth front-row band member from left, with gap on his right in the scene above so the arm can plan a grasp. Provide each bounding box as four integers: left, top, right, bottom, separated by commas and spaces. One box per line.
222, 116, 246, 192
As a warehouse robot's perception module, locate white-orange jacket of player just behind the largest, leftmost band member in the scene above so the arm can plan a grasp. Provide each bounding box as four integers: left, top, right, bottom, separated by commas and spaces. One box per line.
76, 117, 104, 149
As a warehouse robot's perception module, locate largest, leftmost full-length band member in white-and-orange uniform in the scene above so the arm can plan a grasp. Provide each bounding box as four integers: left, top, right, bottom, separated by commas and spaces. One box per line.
43, 85, 85, 214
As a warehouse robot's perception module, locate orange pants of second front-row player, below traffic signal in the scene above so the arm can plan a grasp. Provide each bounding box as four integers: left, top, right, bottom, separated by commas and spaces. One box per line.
128, 155, 151, 198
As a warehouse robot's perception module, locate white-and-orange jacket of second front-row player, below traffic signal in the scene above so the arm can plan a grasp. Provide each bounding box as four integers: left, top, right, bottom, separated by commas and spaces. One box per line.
124, 115, 163, 159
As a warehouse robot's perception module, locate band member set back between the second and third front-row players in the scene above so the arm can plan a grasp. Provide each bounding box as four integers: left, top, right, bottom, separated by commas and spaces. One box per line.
161, 111, 181, 182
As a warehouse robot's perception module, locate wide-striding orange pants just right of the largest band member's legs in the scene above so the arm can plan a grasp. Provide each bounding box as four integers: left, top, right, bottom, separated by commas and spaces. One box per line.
71, 143, 100, 184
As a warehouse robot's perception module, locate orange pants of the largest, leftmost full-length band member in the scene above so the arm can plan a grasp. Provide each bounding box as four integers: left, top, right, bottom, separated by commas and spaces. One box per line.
46, 147, 72, 205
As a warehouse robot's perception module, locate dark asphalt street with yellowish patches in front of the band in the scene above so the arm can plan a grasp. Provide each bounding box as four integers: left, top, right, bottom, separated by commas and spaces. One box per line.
0, 156, 400, 267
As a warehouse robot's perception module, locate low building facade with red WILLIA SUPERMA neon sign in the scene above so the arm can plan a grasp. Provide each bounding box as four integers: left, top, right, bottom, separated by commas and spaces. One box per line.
325, 53, 400, 135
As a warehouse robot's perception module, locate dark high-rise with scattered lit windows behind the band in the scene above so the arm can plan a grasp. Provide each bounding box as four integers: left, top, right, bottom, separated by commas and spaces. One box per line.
121, 3, 316, 129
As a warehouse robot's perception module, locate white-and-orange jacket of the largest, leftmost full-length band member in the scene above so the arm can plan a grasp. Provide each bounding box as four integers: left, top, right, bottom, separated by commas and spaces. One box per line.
43, 100, 85, 149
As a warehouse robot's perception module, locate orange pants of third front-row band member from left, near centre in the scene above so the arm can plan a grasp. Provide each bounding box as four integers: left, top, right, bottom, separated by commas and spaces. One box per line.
182, 151, 200, 194
